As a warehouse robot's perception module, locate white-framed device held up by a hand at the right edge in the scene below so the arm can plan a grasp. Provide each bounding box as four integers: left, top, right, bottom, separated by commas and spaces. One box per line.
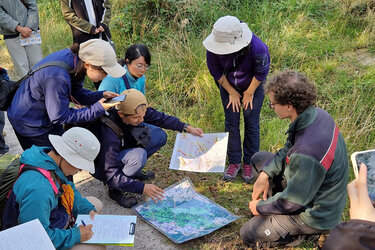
351, 149, 375, 201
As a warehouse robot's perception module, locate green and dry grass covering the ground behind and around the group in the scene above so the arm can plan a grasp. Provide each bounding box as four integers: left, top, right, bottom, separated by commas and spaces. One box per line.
0, 0, 375, 249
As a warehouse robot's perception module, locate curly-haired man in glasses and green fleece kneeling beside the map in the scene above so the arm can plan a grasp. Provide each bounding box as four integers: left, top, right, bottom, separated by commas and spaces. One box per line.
240, 70, 348, 248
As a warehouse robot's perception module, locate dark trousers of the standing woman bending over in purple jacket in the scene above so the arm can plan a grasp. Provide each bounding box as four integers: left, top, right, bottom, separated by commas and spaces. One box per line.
218, 82, 264, 164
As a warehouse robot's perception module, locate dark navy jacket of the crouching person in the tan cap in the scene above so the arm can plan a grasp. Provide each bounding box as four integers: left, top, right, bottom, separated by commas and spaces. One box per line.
89, 108, 185, 194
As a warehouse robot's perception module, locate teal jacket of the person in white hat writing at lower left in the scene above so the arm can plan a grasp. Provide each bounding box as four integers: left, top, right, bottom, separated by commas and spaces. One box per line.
4, 146, 94, 249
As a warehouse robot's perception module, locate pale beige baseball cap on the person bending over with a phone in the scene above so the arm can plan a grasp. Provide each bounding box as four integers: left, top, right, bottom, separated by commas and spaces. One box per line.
78, 39, 126, 78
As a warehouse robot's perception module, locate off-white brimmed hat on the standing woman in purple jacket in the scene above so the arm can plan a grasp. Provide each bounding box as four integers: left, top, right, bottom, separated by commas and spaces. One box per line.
203, 16, 253, 55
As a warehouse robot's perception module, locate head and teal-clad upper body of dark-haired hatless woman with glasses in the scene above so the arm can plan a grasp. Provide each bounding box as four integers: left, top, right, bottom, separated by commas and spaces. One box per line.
99, 44, 151, 94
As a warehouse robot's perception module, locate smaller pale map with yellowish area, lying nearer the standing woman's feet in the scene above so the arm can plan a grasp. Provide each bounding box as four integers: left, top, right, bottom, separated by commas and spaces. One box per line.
169, 133, 228, 173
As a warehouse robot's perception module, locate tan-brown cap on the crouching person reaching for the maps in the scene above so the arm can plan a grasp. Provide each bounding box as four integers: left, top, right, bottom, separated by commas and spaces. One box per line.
117, 89, 147, 115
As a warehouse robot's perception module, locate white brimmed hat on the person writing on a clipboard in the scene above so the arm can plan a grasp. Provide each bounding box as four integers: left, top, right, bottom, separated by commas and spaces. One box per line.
48, 127, 100, 174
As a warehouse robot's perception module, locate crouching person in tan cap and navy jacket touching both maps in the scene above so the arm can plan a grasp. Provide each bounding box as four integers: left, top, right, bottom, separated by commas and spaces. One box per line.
89, 89, 203, 208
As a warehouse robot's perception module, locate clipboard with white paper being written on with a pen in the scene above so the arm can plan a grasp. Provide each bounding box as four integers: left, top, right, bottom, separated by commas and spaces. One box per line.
76, 214, 137, 246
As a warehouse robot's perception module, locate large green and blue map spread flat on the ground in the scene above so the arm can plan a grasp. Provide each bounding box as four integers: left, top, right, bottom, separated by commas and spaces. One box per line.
133, 178, 239, 243
